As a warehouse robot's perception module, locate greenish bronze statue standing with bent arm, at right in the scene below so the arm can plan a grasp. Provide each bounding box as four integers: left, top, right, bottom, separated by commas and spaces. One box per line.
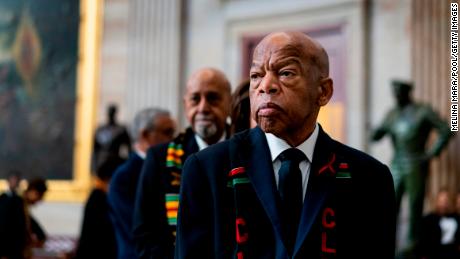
371, 81, 451, 256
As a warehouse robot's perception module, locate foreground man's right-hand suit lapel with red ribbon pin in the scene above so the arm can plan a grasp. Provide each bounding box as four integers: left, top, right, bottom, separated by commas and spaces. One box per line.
294, 126, 336, 255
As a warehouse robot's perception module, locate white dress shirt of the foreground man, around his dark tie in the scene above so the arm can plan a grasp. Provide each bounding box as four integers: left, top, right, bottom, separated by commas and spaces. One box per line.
265, 124, 319, 201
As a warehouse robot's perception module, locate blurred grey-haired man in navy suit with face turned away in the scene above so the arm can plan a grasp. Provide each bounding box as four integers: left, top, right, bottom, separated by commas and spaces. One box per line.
108, 108, 176, 259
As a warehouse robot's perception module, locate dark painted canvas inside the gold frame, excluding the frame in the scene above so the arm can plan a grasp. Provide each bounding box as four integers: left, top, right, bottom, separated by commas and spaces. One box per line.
0, 0, 80, 180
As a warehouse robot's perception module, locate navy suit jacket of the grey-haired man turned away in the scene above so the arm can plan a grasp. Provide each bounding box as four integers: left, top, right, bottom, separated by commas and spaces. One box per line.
107, 152, 144, 259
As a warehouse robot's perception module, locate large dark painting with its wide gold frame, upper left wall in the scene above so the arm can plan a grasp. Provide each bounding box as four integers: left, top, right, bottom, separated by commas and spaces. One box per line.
0, 0, 102, 200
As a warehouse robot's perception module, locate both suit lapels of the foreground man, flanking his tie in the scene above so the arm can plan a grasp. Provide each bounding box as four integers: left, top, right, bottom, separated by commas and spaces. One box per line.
237, 127, 336, 256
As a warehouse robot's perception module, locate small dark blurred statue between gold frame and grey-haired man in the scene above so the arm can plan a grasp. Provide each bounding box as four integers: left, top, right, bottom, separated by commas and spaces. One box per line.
92, 104, 131, 172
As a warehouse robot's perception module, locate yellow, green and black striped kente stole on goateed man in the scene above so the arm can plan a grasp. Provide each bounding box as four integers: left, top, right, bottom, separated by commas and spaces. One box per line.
165, 133, 185, 226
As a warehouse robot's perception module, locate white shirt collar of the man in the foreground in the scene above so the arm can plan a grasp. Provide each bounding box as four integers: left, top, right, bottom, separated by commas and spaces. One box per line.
265, 123, 319, 162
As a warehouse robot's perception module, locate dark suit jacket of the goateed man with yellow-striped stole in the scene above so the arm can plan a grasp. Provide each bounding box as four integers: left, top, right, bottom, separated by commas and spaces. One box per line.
133, 128, 198, 258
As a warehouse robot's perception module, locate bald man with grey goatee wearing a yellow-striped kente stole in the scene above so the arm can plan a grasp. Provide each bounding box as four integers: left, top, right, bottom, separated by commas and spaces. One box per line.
133, 68, 231, 258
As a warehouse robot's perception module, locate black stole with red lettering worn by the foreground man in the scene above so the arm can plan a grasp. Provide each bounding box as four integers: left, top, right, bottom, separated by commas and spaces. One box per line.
227, 155, 351, 259
